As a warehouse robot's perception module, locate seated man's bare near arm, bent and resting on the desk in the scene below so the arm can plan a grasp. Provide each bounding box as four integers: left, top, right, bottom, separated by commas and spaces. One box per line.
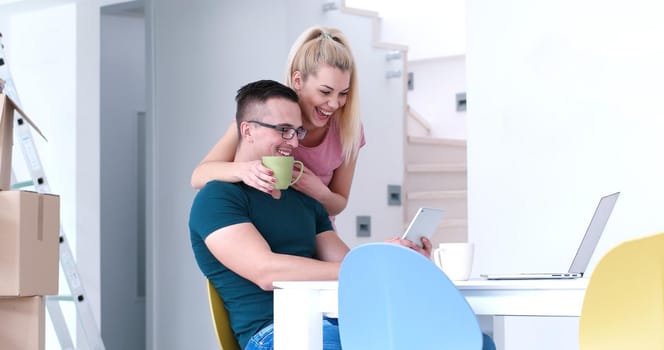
205, 223, 348, 290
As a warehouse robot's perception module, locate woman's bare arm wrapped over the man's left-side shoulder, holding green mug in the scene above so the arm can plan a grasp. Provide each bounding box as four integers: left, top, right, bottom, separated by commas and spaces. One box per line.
191, 121, 274, 193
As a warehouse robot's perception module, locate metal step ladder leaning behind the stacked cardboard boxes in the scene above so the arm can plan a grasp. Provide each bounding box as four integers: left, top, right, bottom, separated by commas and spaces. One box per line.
0, 33, 105, 350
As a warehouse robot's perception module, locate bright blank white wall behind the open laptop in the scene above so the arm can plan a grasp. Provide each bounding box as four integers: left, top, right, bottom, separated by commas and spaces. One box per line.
467, 0, 664, 348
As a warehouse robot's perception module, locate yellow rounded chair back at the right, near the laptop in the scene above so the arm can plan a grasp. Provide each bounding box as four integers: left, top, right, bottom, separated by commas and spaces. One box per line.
579, 233, 664, 350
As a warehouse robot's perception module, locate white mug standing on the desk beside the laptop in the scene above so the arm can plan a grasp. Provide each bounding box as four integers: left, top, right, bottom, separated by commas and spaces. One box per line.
432, 243, 475, 281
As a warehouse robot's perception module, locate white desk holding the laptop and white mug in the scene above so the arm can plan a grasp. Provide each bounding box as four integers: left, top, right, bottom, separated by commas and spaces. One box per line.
274, 278, 588, 350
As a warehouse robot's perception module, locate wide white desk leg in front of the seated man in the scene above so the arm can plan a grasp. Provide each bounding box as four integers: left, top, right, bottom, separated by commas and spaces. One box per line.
274, 289, 323, 350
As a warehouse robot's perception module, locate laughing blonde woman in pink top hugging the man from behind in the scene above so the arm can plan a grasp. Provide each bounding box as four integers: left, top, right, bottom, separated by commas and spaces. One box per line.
191, 27, 365, 217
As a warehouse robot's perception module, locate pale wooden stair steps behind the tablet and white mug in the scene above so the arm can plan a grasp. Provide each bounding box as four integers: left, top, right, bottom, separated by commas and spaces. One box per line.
403, 108, 468, 246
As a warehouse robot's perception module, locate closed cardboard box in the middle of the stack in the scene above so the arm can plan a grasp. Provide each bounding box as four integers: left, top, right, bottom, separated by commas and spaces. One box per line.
0, 191, 60, 296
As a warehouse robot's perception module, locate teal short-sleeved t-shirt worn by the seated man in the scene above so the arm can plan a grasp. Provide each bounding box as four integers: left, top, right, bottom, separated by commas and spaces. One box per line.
189, 181, 333, 348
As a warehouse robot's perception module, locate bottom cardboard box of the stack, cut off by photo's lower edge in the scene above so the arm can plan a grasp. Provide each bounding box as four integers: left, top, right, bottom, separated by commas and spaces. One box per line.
0, 296, 46, 350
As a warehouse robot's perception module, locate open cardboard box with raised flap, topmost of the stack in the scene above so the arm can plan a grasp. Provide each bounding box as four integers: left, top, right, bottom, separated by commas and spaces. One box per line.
0, 94, 44, 191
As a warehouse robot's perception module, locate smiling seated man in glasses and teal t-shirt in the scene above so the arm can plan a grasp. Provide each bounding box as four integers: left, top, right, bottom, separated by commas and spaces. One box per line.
189, 80, 431, 350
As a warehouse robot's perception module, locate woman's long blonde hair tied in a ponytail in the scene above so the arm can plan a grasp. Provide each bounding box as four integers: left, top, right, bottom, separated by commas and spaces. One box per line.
286, 27, 362, 162
